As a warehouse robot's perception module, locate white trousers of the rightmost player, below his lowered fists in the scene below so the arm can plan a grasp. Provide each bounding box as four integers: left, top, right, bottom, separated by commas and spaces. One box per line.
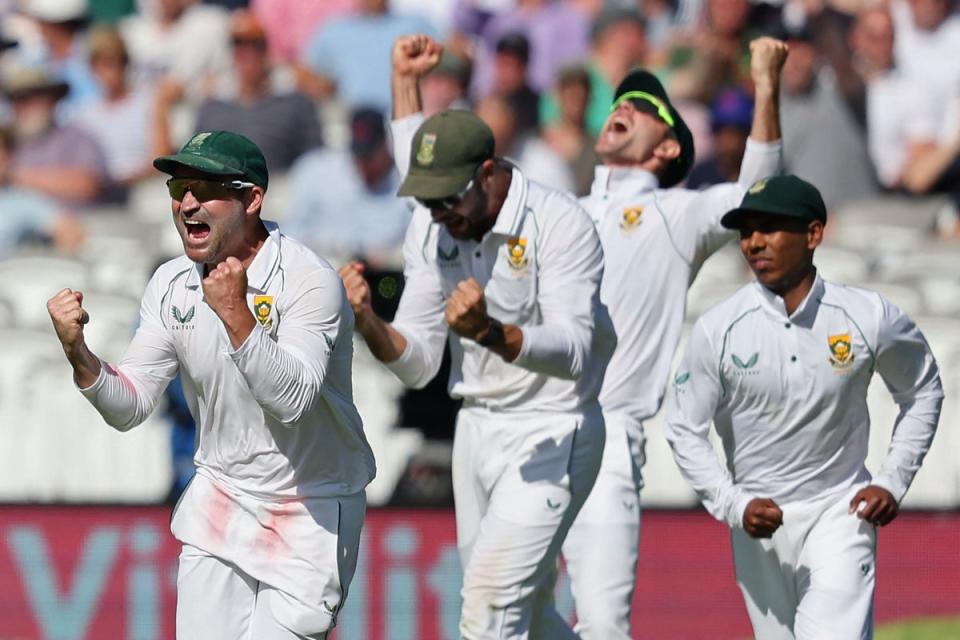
732, 485, 877, 640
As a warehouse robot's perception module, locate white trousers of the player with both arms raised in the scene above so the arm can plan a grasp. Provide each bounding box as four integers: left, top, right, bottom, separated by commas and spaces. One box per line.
563, 412, 644, 640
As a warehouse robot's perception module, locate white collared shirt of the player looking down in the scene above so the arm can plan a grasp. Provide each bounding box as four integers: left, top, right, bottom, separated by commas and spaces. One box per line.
387, 159, 614, 412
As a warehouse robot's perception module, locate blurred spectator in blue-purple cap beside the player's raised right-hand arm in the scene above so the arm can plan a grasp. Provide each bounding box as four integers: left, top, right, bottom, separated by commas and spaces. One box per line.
687, 87, 753, 189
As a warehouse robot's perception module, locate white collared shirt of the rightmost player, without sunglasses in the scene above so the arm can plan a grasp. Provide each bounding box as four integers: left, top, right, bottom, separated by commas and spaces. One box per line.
666, 275, 943, 526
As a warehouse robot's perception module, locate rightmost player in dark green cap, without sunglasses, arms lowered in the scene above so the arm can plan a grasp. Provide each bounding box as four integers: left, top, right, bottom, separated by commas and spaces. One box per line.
667, 176, 943, 640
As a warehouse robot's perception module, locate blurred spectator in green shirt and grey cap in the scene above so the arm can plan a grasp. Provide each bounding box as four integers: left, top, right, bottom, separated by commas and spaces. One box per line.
540, 7, 646, 136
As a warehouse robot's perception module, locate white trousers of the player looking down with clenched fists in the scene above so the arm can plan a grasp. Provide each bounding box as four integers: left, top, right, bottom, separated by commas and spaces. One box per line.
452, 408, 604, 640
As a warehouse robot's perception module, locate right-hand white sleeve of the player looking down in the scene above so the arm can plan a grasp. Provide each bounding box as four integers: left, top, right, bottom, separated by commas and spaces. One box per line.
514, 197, 603, 380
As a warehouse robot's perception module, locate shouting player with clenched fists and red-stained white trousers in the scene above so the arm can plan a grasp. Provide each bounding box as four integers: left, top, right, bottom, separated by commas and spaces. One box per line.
47, 131, 375, 640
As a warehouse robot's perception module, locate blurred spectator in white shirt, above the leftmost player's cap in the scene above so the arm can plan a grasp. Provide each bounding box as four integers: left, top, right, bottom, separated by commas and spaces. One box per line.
120, 0, 230, 105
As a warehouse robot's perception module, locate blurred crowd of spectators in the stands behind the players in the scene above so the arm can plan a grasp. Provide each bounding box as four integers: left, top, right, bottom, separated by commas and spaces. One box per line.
0, 0, 960, 257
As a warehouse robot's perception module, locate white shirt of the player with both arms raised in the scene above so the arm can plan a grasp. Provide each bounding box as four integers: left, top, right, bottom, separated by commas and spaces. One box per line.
580, 140, 782, 421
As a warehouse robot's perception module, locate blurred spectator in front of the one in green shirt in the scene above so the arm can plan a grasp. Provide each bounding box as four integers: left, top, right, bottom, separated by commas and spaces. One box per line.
543, 66, 598, 196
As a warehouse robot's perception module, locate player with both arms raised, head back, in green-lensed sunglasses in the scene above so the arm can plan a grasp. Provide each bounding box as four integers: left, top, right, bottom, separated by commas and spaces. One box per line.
392, 36, 787, 640
